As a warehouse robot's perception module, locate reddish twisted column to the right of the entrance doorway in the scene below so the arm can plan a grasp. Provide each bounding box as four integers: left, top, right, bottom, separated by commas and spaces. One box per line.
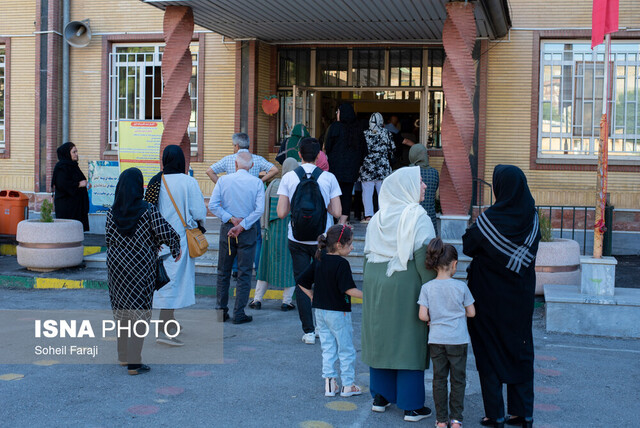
440, 2, 476, 215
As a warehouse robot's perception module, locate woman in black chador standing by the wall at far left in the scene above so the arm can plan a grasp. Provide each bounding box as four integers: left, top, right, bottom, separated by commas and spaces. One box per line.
51, 143, 89, 232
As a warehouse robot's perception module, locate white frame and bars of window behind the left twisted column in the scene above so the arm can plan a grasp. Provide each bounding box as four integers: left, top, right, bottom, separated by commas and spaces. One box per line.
107, 42, 200, 157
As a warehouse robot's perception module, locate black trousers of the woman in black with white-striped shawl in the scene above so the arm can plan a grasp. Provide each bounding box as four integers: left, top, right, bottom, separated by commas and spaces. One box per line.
479, 373, 533, 419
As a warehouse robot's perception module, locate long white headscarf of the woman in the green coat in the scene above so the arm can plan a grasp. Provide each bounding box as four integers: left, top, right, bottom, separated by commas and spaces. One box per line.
364, 166, 436, 276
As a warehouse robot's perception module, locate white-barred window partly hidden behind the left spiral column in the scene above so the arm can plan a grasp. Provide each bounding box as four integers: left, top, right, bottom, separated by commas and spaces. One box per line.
109, 44, 198, 156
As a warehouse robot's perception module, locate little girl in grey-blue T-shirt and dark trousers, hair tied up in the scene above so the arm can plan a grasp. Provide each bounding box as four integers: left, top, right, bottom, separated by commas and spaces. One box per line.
418, 238, 476, 428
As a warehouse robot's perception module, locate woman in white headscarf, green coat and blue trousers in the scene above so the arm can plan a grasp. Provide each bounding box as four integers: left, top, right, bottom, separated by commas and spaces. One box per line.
362, 167, 436, 421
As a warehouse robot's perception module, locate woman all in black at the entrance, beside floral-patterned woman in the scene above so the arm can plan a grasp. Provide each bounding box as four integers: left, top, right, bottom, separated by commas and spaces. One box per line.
324, 104, 368, 224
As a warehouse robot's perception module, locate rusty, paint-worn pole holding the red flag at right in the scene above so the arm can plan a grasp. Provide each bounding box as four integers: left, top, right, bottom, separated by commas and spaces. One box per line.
585, 34, 611, 259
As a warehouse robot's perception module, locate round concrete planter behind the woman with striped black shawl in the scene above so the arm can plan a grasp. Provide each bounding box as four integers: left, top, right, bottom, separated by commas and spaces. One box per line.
536, 239, 580, 296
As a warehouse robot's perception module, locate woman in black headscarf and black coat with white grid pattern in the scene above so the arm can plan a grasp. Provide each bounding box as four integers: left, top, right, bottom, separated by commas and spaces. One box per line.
106, 168, 180, 375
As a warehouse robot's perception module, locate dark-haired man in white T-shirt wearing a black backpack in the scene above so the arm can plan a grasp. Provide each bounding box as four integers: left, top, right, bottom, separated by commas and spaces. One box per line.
277, 138, 342, 344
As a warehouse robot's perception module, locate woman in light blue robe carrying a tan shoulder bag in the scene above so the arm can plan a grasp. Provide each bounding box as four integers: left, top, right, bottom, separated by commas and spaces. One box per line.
145, 144, 207, 346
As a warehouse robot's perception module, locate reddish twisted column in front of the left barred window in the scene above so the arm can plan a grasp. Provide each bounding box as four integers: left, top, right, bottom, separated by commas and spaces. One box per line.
160, 6, 193, 169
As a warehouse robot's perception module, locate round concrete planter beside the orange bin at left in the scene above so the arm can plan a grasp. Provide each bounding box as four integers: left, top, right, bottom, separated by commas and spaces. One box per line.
16, 220, 84, 272
